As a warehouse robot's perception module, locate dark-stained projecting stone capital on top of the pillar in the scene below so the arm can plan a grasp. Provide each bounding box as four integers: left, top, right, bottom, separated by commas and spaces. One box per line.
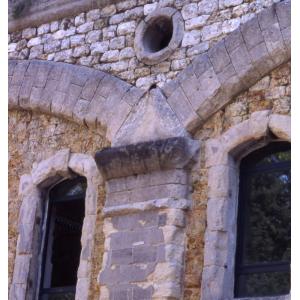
95, 137, 199, 180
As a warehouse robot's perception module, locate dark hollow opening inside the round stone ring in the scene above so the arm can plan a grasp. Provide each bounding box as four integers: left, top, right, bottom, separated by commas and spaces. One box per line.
143, 17, 173, 53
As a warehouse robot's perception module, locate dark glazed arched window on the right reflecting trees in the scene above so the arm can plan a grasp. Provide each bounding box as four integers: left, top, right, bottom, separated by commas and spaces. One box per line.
234, 142, 291, 297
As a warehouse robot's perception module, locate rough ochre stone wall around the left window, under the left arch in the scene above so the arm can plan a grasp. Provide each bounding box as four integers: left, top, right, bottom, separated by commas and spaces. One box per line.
8, 110, 109, 299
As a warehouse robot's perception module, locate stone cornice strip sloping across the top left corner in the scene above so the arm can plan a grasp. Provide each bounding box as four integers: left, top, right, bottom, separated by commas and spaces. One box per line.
8, 0, 121, 33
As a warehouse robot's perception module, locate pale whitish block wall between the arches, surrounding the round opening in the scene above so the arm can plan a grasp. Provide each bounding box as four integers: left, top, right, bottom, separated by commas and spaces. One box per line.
8, 0, 279, 89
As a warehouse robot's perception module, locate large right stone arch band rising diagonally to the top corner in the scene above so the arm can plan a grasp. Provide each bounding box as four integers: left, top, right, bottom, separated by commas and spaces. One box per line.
163, 0, 291, 133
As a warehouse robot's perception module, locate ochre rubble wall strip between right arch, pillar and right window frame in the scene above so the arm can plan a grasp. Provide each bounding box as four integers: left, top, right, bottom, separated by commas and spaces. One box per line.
184, 63, 291, 300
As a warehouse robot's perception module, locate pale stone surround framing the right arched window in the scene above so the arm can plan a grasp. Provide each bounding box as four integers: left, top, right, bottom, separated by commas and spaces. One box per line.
201, 110, 291, 300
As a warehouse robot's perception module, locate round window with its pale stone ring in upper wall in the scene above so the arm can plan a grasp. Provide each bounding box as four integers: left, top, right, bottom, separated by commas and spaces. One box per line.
134, 7, 184, 65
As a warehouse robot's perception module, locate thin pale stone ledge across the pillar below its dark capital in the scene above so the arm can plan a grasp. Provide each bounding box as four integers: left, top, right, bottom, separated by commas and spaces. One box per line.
102, 198, 192, 217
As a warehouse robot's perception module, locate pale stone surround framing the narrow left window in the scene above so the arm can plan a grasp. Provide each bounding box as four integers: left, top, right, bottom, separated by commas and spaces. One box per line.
9, 149, 103, 300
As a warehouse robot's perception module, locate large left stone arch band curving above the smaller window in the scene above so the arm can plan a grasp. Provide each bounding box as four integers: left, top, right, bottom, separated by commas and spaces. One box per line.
8, 60, 144, 140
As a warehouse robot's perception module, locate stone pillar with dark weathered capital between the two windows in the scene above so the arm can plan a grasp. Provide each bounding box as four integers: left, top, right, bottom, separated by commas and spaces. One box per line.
95, 138, 199, 300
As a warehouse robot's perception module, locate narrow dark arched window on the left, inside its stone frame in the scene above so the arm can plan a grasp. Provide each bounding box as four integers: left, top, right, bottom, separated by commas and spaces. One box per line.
38, 177, 86, 300
